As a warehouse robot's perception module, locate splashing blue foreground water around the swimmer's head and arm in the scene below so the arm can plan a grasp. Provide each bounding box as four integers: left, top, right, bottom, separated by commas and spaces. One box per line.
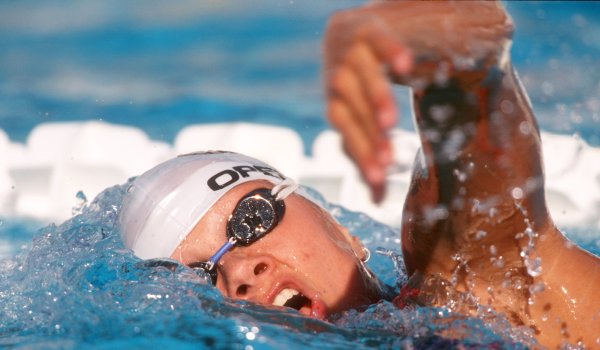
0, 186, 535, 349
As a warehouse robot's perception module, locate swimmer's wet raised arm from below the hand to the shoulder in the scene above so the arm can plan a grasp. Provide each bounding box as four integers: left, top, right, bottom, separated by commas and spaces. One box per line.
408, 66, 600, 345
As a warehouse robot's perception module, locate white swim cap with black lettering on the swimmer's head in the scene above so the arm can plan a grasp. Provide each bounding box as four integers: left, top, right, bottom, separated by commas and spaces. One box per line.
119, 151, 296, 259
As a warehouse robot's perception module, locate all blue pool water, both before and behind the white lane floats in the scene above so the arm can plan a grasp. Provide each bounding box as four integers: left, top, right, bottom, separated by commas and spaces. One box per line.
0, 0, 600, 349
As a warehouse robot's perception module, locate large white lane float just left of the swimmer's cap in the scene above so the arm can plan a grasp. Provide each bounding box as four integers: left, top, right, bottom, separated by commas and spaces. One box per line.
9, 121, 172, 222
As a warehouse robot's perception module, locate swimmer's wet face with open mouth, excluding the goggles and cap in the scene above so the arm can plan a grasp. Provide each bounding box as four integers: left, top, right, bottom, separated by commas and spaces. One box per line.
171, 181, 379, 319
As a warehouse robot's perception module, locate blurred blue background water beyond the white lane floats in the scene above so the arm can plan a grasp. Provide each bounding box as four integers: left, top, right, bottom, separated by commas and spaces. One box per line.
0, 0, 600, 150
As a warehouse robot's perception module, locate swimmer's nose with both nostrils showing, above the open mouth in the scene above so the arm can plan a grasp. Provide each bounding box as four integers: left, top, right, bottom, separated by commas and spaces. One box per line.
220, 254, 275, 302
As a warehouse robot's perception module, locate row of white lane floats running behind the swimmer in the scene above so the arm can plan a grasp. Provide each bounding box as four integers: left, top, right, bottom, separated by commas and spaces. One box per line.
0, 122, 600, 228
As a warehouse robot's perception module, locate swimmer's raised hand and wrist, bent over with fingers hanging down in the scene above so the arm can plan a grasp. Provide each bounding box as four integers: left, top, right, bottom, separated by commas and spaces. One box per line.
324, 1, 512, 202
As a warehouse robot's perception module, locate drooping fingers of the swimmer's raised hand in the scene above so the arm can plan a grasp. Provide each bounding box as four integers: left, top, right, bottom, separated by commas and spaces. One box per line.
326, 16, 412, 202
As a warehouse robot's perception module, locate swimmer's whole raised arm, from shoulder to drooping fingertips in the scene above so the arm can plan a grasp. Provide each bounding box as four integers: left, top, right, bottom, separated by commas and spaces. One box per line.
325, 2, 600, 346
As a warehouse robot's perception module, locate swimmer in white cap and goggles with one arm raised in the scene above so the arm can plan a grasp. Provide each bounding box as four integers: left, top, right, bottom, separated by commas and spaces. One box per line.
120, 2, 600, 347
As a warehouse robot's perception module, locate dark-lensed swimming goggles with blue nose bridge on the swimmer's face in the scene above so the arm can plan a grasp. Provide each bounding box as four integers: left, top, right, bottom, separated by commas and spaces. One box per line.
189, 179, 298, 285
